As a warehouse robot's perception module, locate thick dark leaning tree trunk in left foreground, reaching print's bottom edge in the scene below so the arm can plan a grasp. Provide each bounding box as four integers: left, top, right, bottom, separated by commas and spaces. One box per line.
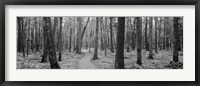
43, 17, 60, 69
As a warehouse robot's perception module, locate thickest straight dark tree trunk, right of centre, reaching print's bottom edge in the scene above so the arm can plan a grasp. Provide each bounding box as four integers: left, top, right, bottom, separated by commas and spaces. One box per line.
115, 17, 125, 69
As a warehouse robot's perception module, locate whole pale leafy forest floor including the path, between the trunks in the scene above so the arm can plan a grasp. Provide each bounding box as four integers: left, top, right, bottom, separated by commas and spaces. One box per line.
17, 50, 183, 69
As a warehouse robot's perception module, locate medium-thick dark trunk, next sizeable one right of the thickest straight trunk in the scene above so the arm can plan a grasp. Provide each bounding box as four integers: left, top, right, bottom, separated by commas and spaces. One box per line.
135, 17, 142, 65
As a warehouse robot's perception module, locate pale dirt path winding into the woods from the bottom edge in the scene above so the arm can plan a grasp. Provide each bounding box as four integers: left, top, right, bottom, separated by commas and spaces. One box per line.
78, 53, 98, 69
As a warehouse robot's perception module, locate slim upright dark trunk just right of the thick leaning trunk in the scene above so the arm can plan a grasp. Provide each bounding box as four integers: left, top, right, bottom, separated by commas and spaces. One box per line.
58, 17, 62, 61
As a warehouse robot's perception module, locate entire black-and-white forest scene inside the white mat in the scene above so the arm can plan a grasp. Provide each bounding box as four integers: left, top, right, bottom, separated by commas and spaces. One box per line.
16, 16, 183, 69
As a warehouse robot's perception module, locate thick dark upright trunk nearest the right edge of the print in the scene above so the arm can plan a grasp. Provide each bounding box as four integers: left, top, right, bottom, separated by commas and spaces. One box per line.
173, 17, 180, 62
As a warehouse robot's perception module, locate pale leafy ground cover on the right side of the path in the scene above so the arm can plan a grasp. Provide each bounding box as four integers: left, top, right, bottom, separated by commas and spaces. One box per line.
93, 50, 183, 69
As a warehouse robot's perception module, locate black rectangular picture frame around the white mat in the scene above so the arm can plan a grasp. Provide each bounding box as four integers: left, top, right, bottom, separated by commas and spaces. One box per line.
0, 0, 200, 86
